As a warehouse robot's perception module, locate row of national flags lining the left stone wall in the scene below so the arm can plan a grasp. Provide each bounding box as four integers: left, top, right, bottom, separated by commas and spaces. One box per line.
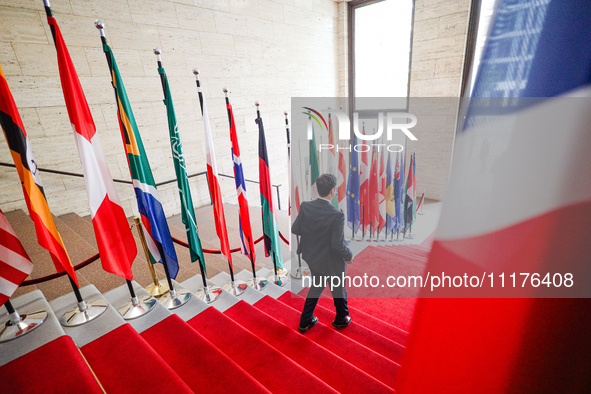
0, 7, 283, 305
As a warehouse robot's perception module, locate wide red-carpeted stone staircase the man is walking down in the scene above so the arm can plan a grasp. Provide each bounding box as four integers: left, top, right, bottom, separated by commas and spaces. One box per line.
0, 212, 426, 393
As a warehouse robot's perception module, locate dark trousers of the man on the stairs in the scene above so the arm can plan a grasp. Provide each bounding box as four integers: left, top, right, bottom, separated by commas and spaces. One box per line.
300, 269, 349, 327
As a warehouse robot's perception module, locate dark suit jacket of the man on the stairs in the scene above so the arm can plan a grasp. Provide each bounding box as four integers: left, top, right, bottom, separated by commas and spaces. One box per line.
291, 198, 353, 276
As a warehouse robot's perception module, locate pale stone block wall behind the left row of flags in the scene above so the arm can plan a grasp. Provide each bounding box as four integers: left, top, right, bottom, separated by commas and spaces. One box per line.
0, 0, 343, 215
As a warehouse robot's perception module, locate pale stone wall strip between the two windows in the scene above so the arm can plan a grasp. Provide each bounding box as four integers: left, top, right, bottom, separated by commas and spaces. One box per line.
407, 0, 470, 200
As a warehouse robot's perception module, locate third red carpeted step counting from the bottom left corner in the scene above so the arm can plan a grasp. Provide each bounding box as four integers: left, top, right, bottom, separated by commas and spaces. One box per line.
141, 307, 269, 393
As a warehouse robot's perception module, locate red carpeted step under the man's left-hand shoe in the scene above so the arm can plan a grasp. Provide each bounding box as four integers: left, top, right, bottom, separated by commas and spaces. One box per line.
254, 296, 400, 388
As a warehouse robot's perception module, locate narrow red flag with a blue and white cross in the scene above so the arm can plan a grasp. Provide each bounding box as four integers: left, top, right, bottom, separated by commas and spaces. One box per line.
226, 99, 256, 262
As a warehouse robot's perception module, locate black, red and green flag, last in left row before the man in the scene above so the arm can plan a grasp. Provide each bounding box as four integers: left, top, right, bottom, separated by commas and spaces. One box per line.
255, 111, 284, 269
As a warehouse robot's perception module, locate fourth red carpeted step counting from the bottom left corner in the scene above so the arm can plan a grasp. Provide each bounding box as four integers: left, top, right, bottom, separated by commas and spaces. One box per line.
187, 308, 336, 393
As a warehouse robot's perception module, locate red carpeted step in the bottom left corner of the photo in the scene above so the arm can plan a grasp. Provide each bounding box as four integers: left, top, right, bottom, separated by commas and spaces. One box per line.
0, 335, 103, 394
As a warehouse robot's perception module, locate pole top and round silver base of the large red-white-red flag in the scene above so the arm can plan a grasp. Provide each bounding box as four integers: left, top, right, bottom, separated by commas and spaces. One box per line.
43, 0, 109, 327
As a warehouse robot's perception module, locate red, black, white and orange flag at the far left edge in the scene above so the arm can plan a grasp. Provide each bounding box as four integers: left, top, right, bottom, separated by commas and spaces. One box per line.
0, 62, 78, 284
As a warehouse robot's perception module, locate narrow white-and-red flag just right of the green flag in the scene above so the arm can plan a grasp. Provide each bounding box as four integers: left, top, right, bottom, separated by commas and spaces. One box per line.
197, 83, 232, 267
